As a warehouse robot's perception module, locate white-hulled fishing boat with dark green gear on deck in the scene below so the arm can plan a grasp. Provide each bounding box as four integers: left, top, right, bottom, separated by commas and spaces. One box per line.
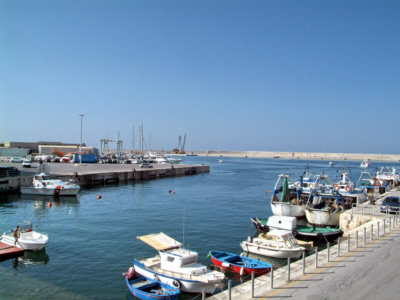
271, 174, 306, 219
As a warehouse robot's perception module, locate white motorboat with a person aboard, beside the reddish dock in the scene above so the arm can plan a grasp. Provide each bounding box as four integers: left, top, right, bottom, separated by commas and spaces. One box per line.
0, 224, 49, 251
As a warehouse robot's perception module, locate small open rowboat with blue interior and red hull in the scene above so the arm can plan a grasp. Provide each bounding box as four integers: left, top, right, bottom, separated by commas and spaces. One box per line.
208, 251, 274, 276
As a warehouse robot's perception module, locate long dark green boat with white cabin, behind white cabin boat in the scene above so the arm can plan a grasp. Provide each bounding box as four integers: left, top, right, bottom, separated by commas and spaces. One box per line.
251, 216, 343, 243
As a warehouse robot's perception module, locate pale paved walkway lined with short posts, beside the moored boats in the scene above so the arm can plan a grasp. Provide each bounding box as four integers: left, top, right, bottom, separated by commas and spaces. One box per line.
207, 191, 400, 300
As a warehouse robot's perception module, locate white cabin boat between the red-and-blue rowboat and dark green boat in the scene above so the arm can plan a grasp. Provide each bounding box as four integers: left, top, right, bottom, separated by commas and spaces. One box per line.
240, 229, 305, 258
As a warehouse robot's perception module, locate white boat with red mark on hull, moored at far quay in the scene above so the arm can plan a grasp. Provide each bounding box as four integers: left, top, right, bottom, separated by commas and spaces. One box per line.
21, 173, 80, 196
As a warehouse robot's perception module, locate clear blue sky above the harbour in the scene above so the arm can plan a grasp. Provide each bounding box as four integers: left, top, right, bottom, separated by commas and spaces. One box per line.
0, 0, 400, 154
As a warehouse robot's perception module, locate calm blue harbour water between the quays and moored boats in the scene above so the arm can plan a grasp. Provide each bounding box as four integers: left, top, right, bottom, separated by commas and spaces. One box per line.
0, 157, 399, 299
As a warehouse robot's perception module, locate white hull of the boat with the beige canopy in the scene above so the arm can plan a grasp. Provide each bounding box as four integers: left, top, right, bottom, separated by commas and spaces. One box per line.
133, 260, 218, 295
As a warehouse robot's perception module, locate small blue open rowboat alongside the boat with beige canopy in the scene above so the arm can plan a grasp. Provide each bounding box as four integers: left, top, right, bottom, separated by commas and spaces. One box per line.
125, 267, 181, 300
